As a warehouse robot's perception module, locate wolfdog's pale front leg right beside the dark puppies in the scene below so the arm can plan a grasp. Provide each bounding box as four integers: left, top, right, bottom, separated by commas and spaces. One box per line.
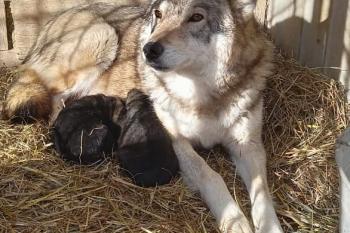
173, 138, 252, 233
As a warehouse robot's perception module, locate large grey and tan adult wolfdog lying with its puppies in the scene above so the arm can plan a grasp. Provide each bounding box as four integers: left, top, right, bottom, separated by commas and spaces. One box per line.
4, 0, 282, 233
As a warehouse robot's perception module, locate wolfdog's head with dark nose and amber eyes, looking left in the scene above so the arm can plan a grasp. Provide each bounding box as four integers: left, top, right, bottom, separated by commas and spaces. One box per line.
141, 0, 255, 72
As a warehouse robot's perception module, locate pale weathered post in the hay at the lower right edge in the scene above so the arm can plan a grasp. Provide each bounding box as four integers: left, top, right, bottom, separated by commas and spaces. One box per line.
336, 128, 350, 233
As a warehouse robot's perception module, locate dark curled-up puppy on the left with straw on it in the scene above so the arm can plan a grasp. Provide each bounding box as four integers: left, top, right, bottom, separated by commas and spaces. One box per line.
53, 95, 125, 164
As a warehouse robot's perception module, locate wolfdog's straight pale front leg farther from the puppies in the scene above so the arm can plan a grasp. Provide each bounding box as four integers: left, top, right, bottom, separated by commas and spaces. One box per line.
226, 106, 283, 233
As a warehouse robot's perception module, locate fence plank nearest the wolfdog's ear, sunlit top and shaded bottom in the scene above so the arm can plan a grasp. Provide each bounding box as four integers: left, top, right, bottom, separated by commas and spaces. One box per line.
268, 0, 308, 57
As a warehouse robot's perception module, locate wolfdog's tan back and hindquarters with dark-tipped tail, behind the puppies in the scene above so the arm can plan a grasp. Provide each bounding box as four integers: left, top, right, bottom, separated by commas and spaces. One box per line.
5, 0, 146, 120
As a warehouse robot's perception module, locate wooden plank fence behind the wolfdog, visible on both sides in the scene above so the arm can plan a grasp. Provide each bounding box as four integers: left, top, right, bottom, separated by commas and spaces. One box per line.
0, 0, 350, 97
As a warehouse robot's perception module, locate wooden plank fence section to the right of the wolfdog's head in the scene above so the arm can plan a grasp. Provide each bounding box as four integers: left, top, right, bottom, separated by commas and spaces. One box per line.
257, 0, 350, 99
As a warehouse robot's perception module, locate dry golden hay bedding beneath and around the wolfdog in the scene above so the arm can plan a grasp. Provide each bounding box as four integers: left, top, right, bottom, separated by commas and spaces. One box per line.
0, 55, 347, 233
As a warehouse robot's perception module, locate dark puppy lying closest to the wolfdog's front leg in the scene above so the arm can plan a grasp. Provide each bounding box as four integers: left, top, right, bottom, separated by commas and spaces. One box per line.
117, 89, 179, 187
